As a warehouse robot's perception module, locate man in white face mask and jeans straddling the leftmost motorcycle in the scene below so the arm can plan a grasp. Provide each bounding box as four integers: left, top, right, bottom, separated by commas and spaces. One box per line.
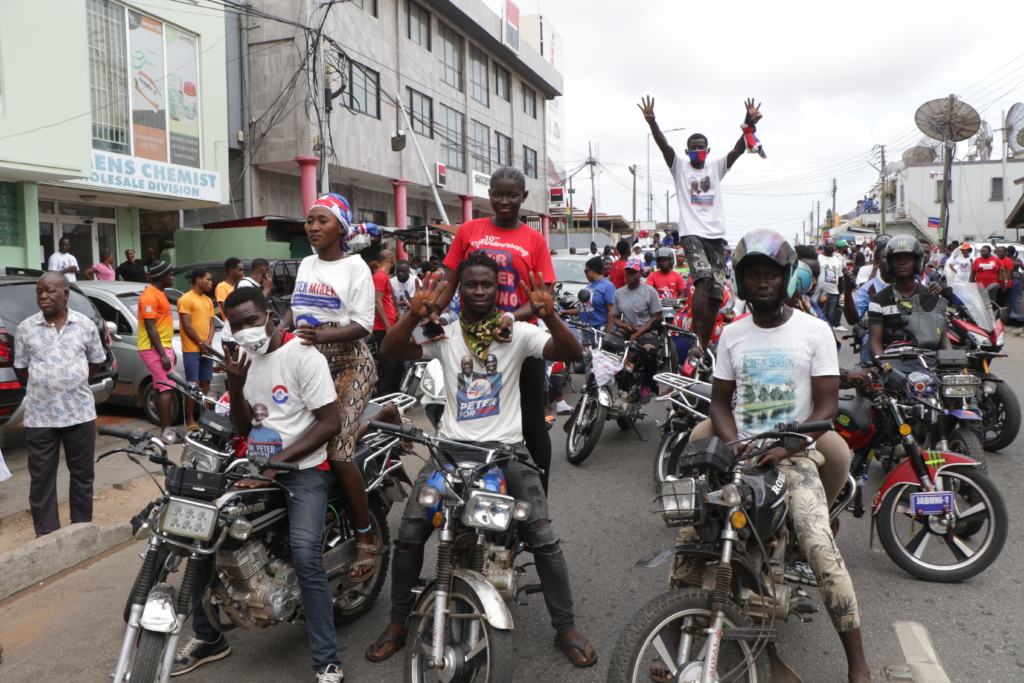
171, 287, 345, 683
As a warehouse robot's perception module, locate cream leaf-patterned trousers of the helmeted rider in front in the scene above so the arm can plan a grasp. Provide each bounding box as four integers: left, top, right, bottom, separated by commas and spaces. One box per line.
669, 449, 860, 633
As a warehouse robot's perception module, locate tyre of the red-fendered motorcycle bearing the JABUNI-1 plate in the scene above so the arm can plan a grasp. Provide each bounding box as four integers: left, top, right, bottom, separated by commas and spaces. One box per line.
877, 467, 1008, 584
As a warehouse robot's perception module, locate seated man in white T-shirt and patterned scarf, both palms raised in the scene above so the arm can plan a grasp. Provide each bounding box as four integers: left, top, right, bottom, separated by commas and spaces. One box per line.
366, 251, 597, 667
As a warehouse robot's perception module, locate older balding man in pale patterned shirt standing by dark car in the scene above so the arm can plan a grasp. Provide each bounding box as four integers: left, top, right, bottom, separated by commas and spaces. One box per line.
14, 272, 106, 538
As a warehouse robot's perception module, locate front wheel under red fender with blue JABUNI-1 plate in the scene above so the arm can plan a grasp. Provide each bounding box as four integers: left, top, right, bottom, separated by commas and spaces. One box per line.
877, 467, 1008, 583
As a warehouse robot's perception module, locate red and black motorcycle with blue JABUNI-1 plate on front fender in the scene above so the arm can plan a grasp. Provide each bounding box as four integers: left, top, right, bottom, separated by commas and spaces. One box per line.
831, 353, 1007, 583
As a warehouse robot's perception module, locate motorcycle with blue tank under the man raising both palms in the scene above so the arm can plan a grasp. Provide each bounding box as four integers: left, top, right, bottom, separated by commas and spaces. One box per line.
370, 422, 541, 683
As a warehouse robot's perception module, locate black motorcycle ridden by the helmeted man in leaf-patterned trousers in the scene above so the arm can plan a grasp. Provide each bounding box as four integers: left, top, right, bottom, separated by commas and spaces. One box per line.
607, 422, 831, 683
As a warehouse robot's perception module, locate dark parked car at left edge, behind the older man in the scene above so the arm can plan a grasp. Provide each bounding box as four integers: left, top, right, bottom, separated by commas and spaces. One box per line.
0, 274, 118, 427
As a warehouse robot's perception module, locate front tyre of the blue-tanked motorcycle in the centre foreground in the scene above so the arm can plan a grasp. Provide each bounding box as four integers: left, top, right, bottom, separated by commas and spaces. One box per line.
402, 577, 515, 683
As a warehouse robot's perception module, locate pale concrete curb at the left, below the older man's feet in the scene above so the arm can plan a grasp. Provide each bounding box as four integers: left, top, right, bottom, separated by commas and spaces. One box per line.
0, 523, 131, 600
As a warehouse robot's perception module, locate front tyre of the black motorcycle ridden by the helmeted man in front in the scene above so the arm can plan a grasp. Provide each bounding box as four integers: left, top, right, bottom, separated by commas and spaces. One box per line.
607, 589, 771, 683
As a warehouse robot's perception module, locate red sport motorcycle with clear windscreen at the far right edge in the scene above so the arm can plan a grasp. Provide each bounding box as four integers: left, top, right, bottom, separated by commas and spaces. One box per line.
946, 283, 1021, 451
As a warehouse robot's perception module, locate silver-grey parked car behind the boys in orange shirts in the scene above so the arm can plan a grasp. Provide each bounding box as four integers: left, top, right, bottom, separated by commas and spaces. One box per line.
79, 281, 227, 425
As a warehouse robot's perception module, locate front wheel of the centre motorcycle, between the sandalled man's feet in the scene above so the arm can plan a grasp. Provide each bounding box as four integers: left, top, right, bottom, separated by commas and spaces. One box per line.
404, 577, 514, 683
